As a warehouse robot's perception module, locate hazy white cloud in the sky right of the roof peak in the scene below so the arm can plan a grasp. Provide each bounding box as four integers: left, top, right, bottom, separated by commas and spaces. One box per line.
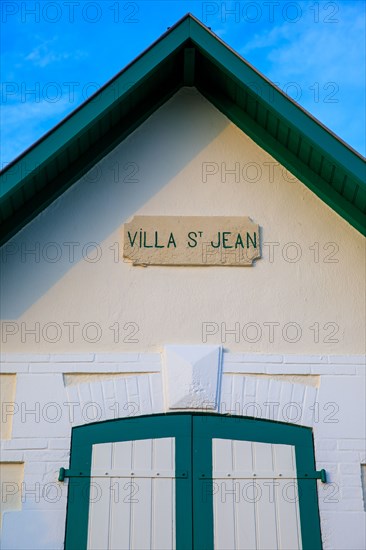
240, 3, 366, 152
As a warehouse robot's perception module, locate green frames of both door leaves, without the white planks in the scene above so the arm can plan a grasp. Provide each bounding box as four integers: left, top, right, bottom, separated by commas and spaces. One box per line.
64, 412, 322, 550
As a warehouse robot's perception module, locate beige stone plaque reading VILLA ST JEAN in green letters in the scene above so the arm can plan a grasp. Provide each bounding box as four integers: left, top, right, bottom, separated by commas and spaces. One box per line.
123, 216, 260, 266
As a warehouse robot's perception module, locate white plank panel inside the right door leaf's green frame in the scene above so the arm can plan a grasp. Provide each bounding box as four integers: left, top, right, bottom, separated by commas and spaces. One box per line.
212, 439, 302, 550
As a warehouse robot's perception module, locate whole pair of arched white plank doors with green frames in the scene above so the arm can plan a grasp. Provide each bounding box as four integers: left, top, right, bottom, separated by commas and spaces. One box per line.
65, 414, 323, 550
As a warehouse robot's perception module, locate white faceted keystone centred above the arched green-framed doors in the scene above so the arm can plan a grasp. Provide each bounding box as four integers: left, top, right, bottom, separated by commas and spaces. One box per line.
164, 346, 221, 410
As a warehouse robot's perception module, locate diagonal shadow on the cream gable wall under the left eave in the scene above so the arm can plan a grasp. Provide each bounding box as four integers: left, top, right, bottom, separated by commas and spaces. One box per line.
1, 88, 229, 320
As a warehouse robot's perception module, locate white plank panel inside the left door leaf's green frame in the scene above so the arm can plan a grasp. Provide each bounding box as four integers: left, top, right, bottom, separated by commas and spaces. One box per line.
88, 437, 176, 550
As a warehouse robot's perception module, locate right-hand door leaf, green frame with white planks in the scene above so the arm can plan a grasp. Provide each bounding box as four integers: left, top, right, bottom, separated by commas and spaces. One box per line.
192, 415, 322, 550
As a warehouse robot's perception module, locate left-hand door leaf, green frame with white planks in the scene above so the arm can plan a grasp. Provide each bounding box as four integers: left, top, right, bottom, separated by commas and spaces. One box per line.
65, 414, 192, 550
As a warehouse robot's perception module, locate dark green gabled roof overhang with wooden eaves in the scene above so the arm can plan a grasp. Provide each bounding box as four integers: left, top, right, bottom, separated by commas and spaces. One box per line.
0, 14, 366, 244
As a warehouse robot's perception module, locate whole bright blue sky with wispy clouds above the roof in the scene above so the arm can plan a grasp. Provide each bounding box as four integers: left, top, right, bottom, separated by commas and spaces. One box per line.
1, 0, 366, 167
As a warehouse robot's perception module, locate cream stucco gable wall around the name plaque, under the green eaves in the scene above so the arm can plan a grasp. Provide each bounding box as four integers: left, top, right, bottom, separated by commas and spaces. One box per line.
1, 88, 365, 354
